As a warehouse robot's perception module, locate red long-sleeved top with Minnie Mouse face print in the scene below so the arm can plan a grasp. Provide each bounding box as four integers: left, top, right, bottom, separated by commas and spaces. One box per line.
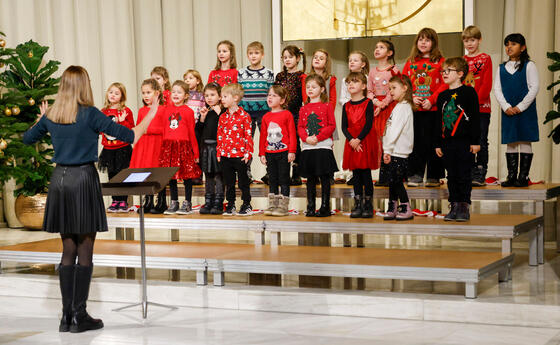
163, 104, 198, 158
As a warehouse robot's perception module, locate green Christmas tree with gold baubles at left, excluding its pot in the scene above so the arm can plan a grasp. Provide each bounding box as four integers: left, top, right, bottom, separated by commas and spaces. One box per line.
0, 33, 60, 195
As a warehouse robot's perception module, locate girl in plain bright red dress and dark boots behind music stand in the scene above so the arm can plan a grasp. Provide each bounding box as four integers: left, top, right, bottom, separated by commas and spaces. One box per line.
130, 79, 167, 213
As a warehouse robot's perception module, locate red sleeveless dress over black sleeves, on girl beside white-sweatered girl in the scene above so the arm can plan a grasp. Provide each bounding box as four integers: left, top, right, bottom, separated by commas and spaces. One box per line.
342, 98, 381, 170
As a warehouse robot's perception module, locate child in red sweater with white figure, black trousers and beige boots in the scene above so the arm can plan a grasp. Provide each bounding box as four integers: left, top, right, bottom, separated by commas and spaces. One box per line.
259, 85, 297, 216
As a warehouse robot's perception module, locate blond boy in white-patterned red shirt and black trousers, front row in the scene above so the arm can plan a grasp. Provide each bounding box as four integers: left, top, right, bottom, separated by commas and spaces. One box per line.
216, 83, 253, 216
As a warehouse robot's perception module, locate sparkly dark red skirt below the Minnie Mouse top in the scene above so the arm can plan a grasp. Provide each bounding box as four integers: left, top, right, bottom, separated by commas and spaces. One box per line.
159, 140, 201, 180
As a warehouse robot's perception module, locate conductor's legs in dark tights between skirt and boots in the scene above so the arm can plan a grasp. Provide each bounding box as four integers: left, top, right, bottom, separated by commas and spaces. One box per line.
60, 232, 96, 266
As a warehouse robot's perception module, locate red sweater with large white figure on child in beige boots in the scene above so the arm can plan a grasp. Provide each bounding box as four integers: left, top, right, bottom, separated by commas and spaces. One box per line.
259, 110, 297, 156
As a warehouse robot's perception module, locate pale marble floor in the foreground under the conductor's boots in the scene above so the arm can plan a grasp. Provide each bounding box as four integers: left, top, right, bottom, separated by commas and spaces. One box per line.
0, 296, 560, 345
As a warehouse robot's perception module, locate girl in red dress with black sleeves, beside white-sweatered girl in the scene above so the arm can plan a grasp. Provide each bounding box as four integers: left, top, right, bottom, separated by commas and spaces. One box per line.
342, 72, 381, 218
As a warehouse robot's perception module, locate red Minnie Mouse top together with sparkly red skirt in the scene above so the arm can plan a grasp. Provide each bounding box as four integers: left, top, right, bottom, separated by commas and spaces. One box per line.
159, 104, 201, 180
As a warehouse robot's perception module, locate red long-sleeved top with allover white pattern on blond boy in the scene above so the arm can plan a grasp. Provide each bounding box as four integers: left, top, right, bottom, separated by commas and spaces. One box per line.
216, 107, 253, 158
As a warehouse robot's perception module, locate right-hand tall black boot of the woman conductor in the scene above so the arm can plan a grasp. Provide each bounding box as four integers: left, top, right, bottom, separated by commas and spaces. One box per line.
70, 265, 103, 333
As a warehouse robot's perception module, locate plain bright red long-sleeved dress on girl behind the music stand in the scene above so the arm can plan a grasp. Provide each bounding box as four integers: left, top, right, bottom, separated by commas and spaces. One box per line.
130, 105, 165, 168
